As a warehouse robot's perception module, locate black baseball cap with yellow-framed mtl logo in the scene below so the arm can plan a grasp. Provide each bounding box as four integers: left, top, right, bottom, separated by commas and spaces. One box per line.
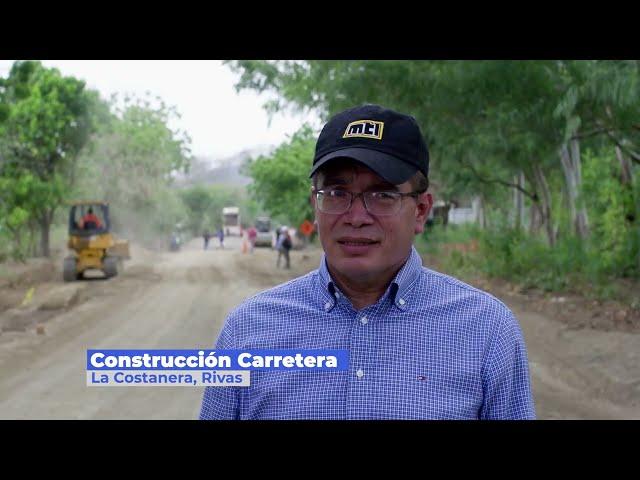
309, 105, 429, 185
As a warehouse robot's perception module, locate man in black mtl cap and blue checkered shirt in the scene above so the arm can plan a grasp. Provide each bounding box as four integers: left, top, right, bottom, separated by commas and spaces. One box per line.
200, 105, 535, 419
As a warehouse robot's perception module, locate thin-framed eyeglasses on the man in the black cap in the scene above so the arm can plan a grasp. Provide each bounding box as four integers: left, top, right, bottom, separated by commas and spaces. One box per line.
315, 190, 424, 216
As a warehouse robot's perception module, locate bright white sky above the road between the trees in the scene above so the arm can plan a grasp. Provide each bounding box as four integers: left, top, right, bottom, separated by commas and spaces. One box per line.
0, 60, 320, 162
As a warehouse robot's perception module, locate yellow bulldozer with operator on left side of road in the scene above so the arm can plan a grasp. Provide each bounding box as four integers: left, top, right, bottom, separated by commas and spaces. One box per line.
62, 202, 131, 282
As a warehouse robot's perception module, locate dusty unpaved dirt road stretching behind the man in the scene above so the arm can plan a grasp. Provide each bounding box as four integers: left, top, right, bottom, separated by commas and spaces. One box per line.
0, 238, 640, 419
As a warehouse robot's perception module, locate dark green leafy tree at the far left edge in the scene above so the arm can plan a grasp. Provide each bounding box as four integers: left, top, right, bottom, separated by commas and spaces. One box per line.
0, 61, 96, 256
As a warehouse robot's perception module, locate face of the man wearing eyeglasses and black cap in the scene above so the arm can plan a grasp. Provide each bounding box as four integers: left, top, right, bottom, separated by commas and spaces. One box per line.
312, 162, 433, 283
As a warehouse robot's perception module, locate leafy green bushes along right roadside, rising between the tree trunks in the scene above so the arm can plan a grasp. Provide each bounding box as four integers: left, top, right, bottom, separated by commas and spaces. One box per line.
416, 150, 640, 298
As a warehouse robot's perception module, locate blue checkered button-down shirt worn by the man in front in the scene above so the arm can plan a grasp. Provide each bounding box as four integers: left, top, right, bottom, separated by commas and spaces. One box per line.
200, 247, 535, 419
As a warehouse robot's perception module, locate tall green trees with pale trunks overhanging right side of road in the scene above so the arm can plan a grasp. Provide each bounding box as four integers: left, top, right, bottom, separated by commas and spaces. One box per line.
228, 60, 640, 260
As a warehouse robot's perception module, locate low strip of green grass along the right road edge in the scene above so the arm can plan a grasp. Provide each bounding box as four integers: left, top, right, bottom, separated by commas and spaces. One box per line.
416, 225, 640, 308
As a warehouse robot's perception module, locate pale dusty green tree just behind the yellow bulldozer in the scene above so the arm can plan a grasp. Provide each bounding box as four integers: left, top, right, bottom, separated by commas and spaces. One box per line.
73, 92, 191, 246
